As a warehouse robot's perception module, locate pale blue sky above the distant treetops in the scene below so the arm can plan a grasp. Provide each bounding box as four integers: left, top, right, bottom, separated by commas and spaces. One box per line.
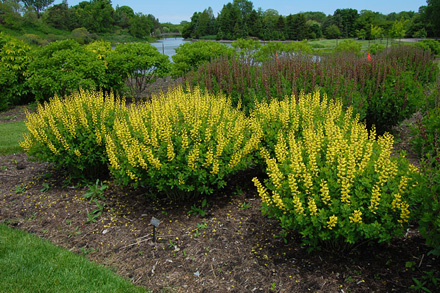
54, 0, 426, 23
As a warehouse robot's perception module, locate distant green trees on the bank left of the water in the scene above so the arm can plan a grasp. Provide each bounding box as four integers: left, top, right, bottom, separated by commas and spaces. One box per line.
0, 0, 178, 38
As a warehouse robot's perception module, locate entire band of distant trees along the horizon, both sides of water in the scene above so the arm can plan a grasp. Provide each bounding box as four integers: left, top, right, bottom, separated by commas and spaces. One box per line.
0, 0, 440, 40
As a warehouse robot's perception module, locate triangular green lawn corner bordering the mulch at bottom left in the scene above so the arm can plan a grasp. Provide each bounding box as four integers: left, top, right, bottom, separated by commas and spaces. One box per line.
0, 224, 146, 292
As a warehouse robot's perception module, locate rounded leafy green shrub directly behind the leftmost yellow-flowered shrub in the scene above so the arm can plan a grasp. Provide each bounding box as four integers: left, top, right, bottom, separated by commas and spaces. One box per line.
27, 40, 108, 101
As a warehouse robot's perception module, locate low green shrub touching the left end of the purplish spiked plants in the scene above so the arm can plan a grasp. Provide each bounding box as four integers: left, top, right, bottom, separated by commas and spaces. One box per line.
172, 41, 233, 76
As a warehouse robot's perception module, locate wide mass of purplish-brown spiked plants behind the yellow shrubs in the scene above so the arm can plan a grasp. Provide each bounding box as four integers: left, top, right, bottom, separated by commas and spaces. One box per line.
184, 46, 438, 133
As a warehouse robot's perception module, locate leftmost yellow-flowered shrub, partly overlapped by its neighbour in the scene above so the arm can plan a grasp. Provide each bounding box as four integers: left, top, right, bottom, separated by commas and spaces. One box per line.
20, 90, 126, 178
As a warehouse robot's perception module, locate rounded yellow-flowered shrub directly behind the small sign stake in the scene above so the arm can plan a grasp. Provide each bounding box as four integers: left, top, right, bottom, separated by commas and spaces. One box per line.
106, 87, 262, 199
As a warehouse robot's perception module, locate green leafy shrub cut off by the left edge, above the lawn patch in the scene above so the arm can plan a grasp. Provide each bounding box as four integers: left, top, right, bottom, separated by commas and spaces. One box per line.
0, 36, 32, 110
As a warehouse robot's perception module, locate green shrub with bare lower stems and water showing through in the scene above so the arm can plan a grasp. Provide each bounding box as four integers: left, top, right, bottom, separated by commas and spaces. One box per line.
105, 43, 170, 97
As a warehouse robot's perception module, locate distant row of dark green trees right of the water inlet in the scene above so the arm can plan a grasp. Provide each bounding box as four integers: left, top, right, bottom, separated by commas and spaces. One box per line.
182, 0, 440, 40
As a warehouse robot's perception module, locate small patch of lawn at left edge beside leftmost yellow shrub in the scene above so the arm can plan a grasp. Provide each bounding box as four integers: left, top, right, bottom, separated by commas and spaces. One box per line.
0, 121, 27, 156
